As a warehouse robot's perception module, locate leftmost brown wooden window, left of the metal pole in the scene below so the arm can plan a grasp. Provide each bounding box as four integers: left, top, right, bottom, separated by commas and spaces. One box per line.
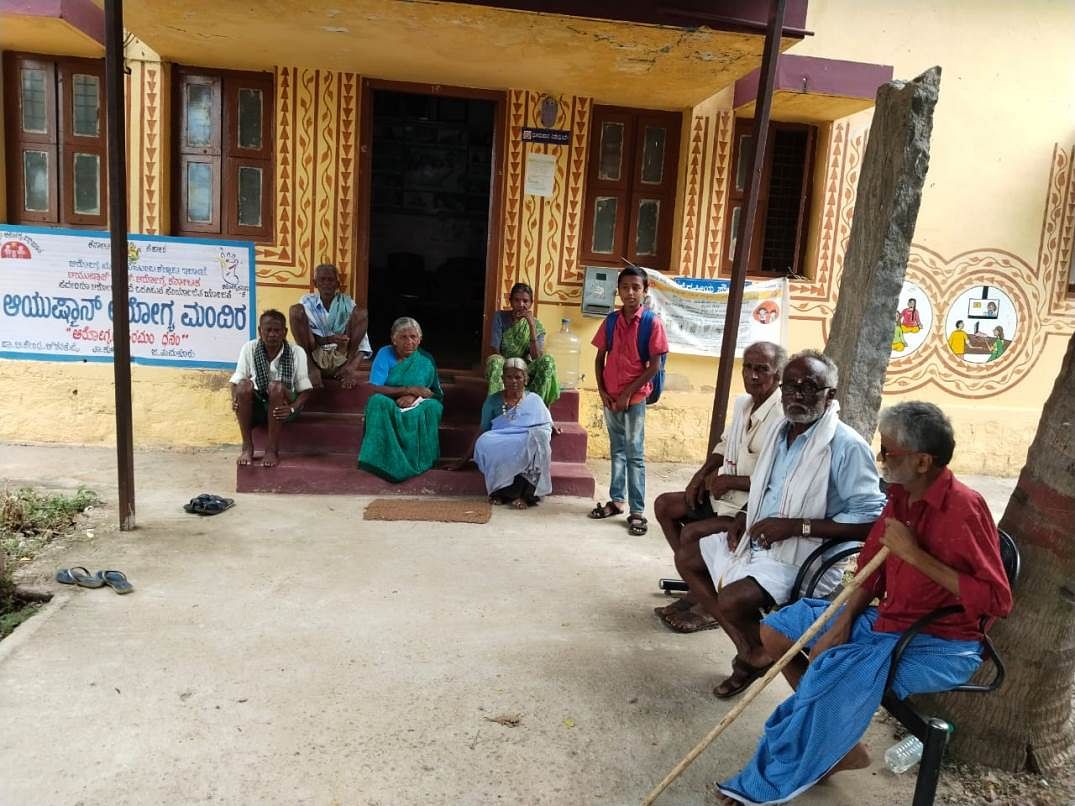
3, 53, 109, 228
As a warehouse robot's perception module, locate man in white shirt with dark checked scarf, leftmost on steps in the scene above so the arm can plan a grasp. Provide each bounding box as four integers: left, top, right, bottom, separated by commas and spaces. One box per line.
231, 311, 313, 467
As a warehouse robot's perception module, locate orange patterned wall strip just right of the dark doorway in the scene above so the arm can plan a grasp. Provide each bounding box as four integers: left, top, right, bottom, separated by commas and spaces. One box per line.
491, 89, 592, 303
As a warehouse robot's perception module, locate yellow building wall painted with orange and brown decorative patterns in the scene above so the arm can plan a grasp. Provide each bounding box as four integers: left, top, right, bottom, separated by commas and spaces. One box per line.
0, 0, 1075, 474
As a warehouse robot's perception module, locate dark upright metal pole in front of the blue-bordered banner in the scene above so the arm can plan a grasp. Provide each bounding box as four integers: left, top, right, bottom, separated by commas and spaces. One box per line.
104, 0, 134, 532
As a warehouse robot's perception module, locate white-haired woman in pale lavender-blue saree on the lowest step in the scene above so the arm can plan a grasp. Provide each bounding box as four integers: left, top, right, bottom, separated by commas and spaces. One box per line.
457, 358, 553, 509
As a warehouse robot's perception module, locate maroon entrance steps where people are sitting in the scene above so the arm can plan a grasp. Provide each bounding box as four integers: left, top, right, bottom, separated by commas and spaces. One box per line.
235, 373, 594, 498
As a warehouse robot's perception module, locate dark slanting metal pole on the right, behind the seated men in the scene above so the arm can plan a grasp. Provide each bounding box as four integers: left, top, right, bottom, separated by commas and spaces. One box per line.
710, 0, 787, 450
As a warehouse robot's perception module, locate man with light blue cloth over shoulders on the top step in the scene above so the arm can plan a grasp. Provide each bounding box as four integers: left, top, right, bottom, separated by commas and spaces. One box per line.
288, 263, 373, 389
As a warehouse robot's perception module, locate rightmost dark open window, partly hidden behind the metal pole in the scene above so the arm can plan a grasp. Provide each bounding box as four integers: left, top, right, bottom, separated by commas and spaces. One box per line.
722, 119, 816, 276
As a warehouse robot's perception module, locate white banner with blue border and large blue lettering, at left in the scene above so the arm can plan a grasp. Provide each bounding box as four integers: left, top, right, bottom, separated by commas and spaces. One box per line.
0, 225, 257, 369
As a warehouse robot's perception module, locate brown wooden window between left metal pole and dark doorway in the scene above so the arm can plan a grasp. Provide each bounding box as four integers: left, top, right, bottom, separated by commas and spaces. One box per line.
172, 68, 275, 241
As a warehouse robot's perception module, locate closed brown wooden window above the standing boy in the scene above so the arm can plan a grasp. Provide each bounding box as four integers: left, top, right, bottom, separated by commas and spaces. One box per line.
582, 106, 683, 271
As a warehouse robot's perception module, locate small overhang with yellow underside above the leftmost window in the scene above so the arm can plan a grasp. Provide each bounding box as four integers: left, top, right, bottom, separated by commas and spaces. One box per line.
0, 0, 104, 58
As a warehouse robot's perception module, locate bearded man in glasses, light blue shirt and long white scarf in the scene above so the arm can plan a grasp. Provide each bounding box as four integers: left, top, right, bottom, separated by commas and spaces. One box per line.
676, 350, 885, 699
